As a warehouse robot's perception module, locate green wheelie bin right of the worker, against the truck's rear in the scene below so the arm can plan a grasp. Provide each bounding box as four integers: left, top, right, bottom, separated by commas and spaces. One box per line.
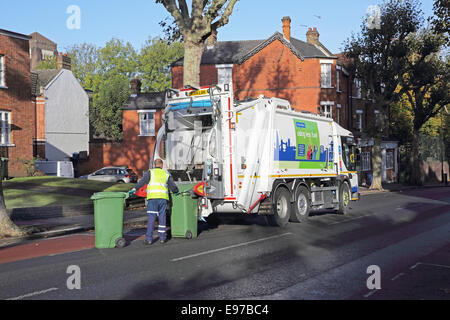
170, 184, 198, 239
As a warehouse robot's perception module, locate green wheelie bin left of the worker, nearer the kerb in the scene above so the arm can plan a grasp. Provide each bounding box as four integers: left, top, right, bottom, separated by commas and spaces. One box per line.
91, 192, 128, 249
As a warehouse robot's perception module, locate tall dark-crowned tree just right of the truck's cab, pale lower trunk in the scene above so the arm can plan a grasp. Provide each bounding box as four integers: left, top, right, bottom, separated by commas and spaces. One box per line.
344, 0, 422, 189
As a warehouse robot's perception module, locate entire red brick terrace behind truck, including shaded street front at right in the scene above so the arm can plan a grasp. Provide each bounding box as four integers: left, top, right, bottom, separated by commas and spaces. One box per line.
172, 17, 398, 183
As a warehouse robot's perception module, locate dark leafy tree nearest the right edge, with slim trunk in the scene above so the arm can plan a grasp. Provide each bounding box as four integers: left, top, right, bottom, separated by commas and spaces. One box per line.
400, 30, 450, 185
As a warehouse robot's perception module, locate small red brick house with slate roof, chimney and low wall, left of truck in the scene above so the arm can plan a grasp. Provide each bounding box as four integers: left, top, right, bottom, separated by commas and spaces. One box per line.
76, 79, 165, 176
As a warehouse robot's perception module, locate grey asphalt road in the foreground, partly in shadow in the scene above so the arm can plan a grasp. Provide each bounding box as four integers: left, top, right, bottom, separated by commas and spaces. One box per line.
0, 188, 450, 300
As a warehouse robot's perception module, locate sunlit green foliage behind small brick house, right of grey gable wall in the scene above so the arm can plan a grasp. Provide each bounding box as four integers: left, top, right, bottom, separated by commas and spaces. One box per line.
67, 38, 183, 140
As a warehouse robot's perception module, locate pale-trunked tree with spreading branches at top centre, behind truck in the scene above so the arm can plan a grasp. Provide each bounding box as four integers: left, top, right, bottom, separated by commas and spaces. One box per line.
156, 0, 237, 87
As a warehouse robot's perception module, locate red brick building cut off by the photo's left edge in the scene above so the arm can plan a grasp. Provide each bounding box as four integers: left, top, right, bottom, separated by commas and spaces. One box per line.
0, 29, 36, 177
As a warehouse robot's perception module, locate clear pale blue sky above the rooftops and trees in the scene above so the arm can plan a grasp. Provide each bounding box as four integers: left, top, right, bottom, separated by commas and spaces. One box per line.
0, 0, 433, 53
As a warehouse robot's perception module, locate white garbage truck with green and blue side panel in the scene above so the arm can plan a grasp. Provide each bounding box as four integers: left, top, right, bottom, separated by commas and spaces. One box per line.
153, 83, 359, 227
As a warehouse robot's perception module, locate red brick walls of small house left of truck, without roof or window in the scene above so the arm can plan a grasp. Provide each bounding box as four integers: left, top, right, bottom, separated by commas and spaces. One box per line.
77, 110, 162, 176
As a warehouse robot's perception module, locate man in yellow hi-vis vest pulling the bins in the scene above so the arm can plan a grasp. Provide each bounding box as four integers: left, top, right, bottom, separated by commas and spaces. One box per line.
128, 159, 179, 245
